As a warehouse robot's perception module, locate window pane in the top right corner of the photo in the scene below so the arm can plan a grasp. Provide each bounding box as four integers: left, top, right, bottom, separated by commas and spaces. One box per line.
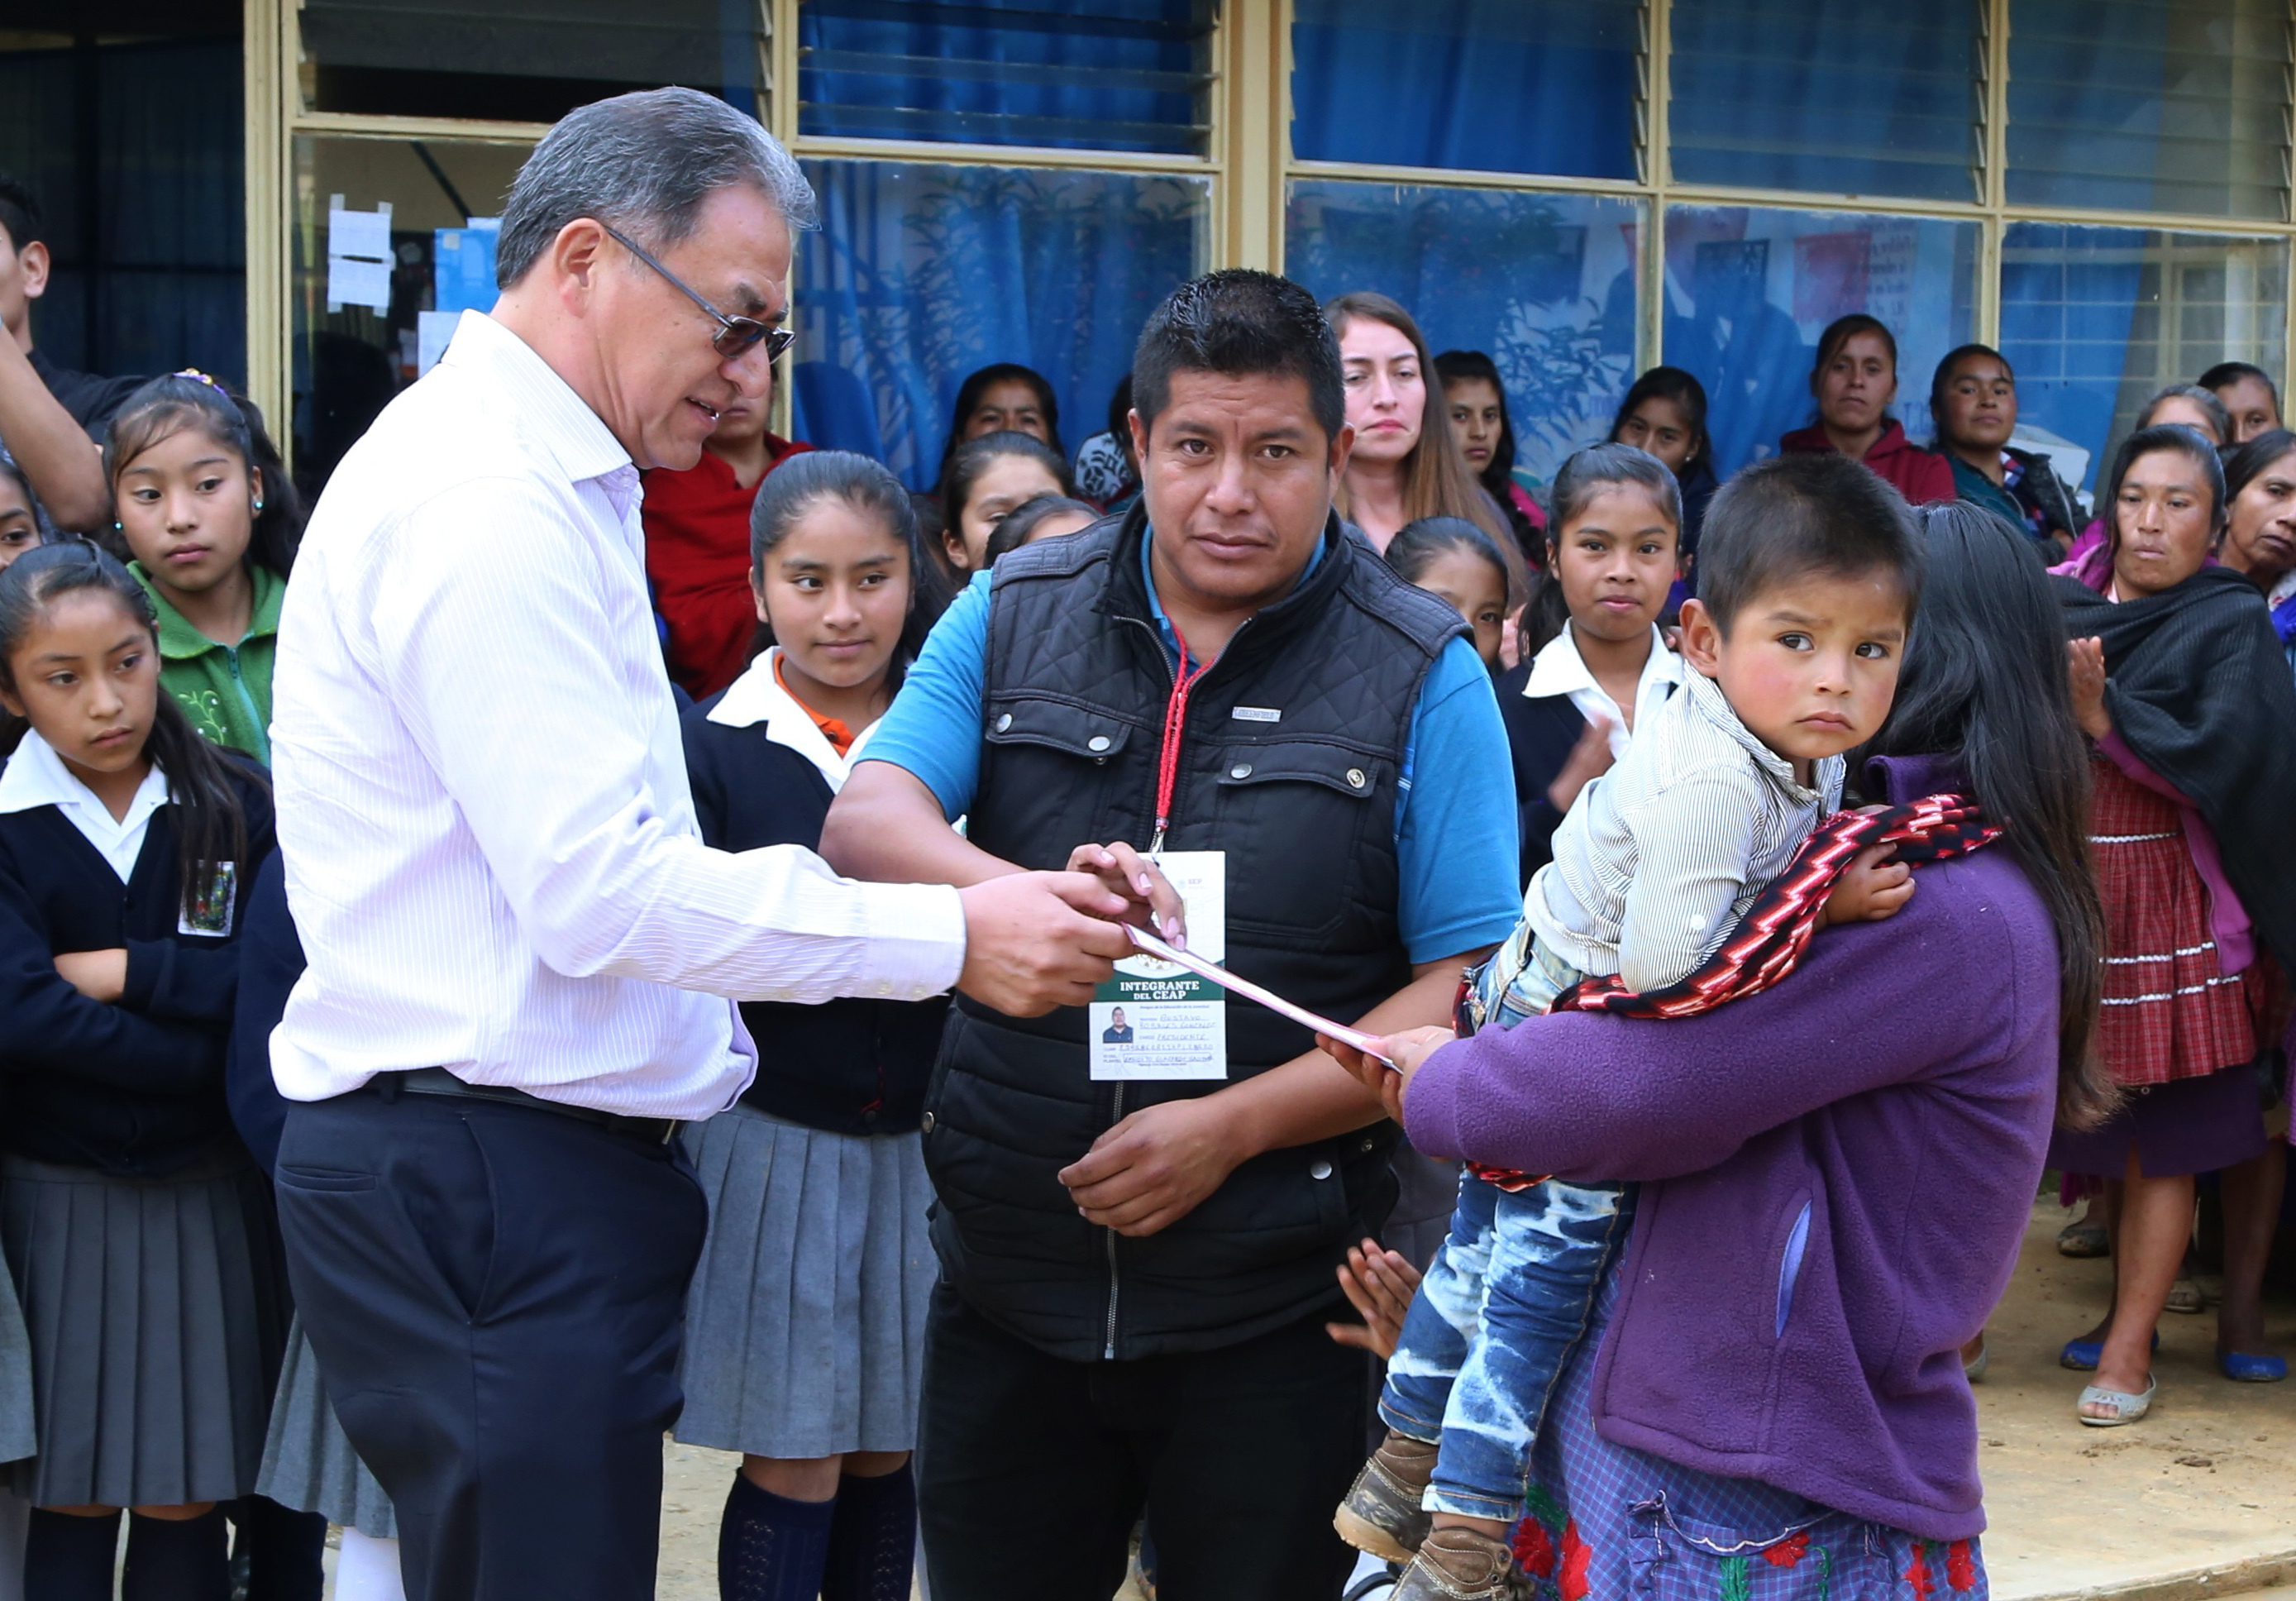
2009, 0, 2289, 221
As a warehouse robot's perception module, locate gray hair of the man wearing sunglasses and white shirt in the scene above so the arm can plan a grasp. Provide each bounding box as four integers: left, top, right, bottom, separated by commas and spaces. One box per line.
494, 88, 818, 289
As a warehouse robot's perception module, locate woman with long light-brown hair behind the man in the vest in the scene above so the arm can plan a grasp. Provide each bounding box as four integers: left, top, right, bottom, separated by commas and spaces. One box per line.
1323, 289, 1529, 588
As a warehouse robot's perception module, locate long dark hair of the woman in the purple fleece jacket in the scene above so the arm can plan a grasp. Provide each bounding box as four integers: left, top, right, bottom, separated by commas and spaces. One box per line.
1853, 501, 2117, 1128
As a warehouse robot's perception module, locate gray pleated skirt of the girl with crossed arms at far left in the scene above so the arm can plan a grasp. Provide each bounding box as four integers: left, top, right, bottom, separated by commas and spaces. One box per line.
0, 1149, 278, 1507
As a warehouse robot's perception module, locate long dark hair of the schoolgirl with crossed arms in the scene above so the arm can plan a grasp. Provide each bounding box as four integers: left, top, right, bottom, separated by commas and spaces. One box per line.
0, 540, 260, 907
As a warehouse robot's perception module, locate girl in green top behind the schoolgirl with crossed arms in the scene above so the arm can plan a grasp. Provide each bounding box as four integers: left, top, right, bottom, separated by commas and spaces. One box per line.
103, 370, 303, 767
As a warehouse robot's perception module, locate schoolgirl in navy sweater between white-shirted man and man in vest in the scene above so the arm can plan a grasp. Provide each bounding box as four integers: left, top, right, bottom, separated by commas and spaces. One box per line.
675, 450, 948, 1601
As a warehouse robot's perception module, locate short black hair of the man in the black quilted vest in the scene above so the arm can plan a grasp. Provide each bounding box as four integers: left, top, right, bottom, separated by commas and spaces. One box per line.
1132, 266, 1348, 439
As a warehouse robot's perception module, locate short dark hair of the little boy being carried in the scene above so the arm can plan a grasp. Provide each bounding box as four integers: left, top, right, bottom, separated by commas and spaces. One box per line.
1699, 450, 1921, 632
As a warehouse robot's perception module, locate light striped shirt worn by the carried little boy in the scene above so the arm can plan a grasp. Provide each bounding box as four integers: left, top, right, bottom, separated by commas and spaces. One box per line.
1522, 671, 1844, 992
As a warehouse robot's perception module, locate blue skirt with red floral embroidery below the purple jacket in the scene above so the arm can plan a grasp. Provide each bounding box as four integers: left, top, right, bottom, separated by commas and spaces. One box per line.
1516, 1265, 1988, 1601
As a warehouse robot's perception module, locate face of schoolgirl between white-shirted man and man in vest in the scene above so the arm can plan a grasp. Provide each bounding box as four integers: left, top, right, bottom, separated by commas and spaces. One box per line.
753, 496, 909, 689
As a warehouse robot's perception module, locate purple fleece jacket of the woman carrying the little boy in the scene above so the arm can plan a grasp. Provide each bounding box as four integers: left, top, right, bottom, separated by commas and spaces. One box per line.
1403, 758, 2057, 1541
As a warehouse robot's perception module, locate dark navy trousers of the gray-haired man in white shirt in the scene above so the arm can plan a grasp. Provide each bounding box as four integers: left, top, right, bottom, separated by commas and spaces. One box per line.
278, 1091, 709, 1601
